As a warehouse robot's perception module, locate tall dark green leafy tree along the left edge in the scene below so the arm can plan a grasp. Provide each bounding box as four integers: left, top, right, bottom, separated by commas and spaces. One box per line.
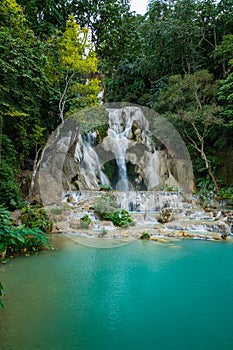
0, 0, 48, 209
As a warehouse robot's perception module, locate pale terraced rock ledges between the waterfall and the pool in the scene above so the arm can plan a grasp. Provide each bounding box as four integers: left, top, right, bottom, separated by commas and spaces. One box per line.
48, 201, 233, 245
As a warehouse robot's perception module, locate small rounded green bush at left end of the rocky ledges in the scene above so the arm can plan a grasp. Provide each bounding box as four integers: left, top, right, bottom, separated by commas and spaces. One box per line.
21, 206, 53, 233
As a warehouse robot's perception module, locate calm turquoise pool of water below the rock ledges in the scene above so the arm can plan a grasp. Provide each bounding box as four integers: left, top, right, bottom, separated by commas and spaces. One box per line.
0, 236, 233, 350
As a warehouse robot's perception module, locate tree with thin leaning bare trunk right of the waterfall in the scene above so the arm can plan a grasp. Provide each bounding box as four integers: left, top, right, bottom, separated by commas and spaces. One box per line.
154, 70, 222, 192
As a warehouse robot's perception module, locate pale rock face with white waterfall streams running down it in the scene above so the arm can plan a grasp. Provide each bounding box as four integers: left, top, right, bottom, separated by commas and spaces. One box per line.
63, 106, 194, 192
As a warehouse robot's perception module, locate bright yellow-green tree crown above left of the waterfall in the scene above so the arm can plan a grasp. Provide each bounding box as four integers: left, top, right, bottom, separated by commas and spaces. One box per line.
47, 16, 100, 121
